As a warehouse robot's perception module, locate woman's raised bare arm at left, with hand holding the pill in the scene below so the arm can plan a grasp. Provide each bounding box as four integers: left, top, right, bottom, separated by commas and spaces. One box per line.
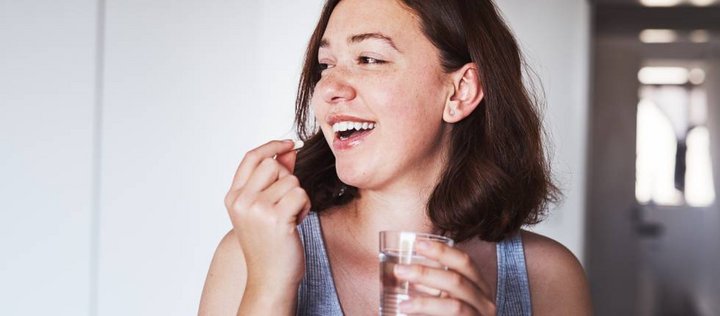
199, 141, 310, 315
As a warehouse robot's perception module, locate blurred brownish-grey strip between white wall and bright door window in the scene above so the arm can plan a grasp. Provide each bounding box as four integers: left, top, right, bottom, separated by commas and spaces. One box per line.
587, 38, 642, 315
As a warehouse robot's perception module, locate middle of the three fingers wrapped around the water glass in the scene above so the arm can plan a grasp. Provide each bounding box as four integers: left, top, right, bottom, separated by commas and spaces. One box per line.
395, 264, 492, 309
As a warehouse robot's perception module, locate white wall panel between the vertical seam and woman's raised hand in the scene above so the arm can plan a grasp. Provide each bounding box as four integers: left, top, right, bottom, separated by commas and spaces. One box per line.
99, 0, 319, 315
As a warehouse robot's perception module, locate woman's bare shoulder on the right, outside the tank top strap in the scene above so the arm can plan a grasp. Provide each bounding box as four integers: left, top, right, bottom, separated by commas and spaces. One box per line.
522, 231, 592, 316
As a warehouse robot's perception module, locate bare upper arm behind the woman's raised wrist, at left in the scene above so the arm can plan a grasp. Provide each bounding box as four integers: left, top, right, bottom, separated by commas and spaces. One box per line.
198, 230, 247, 315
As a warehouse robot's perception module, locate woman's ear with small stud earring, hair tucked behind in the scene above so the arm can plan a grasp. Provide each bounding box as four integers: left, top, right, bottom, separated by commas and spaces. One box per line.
443, 63, 485, 123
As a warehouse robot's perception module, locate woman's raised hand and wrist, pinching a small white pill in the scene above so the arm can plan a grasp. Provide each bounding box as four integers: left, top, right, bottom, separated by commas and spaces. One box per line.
225, 141, 310, 304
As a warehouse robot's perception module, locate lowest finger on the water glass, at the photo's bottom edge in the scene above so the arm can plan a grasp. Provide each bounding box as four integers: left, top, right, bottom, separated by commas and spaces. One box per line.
400, 296, 478, 316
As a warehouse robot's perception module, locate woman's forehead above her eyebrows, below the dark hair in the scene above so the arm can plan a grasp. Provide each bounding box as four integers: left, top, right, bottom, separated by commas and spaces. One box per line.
323, 0, 424, 44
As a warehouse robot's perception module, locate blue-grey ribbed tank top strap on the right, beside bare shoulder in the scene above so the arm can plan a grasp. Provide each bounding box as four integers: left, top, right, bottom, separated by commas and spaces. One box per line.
495, 232, 532, 316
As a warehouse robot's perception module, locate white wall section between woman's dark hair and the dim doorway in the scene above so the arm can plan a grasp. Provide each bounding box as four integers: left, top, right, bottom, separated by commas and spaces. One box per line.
497, 0, 590, 261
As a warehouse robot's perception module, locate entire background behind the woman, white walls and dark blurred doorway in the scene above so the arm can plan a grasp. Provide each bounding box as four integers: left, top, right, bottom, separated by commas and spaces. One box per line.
0, 0, 720, 316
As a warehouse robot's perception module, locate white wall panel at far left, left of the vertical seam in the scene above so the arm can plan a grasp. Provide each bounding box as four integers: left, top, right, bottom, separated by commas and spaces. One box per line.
0, 0, 96, 315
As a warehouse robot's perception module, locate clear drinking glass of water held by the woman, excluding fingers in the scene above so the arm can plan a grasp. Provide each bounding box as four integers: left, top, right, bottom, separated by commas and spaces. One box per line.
379, 231, 453, 315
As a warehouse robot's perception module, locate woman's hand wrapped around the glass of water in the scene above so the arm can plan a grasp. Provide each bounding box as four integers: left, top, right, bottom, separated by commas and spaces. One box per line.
395, 242, 495, 315
